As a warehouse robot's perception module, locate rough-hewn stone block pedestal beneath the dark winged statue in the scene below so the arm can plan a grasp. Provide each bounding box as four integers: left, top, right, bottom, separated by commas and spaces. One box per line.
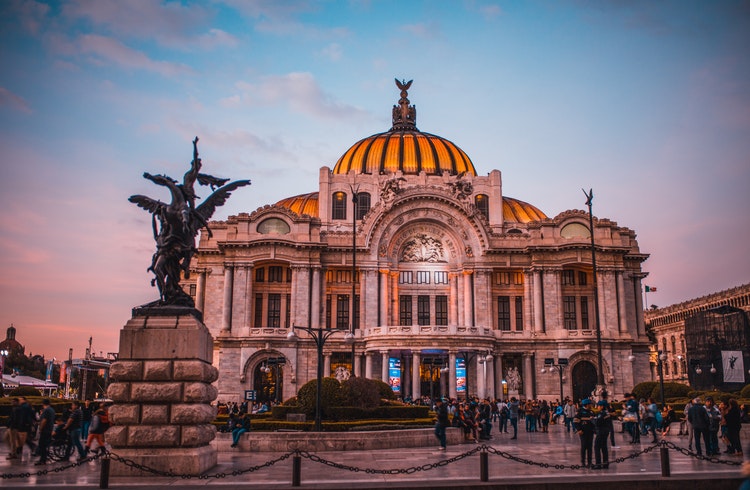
106, 307, 218, 476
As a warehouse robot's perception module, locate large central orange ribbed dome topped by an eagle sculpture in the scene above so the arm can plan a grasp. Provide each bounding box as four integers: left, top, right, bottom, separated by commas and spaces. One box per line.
333, 80, 477, 175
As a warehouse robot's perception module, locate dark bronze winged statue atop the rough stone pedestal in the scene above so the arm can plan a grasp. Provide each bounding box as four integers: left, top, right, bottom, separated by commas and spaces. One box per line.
128, 137, 250, 308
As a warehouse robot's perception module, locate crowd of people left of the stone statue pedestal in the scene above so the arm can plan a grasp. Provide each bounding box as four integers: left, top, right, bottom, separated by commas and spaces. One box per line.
5, 396, 109, 465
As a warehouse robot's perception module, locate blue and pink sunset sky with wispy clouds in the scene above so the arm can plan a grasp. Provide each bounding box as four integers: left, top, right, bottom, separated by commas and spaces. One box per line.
0, 0, 750, 359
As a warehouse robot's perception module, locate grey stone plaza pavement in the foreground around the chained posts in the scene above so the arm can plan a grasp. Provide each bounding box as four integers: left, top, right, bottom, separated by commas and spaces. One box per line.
0, 425, 750, 490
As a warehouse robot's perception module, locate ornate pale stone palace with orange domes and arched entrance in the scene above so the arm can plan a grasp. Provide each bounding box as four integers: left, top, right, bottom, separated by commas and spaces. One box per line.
184, 82, 650, 401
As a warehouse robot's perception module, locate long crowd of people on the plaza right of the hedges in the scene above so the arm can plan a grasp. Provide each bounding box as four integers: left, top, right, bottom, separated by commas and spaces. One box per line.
432, 393, 750, 469
